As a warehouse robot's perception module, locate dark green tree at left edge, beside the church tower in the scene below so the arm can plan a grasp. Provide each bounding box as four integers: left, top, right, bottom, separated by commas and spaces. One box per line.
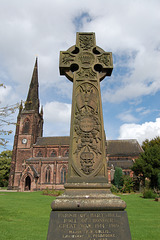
0, 150, 12, 187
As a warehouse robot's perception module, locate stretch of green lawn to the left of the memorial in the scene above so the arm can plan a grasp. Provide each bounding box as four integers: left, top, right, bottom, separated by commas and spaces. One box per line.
0, 192, 53, 240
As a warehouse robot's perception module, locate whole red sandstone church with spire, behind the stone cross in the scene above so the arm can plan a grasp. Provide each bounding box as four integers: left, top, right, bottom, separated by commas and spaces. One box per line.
8, 59, 142, 191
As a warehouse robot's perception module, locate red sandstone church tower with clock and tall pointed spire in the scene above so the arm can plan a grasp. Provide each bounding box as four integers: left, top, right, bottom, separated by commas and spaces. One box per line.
8, 58, 43, 189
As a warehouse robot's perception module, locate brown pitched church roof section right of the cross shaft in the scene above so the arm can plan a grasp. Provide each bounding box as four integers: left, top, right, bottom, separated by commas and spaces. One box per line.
106, 139, 143, 157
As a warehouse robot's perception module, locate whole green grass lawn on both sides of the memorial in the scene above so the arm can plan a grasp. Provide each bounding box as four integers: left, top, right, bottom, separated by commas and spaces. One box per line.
0, 192, 160, 240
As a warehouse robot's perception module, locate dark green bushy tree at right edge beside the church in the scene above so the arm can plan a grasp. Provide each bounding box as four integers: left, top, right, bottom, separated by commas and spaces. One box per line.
132, 137, 160, 188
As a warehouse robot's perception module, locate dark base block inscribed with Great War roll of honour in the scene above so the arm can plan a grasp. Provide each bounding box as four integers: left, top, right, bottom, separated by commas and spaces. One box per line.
47, 211, 131, 240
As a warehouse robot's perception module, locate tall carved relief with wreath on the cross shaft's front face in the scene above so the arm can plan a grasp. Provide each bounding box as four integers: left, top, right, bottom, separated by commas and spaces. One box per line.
74, 83, 101, 175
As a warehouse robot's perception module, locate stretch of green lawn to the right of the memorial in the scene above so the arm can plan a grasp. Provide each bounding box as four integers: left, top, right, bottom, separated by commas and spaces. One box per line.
120, 194, 160, 240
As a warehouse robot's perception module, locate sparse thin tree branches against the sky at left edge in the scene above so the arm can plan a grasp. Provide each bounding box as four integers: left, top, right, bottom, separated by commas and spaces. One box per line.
0, 84, 19, 146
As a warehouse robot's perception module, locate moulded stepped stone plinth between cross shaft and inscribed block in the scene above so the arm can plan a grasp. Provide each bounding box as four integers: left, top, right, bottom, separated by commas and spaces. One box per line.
51, 183, 126, 211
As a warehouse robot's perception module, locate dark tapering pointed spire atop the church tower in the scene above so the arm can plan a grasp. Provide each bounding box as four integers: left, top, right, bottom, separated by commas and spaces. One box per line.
25, 58, 39, 113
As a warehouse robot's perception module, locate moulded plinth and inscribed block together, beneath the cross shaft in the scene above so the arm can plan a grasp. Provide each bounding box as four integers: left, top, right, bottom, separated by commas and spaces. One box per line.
47, 183, 131, 240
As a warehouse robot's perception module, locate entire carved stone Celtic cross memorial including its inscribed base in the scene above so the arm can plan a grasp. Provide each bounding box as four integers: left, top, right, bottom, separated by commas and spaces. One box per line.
47, 33, 131, 240
